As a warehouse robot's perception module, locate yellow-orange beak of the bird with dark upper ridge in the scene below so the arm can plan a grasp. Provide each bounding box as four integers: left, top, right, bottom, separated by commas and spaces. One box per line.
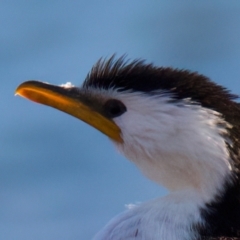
15, 81, 123, 142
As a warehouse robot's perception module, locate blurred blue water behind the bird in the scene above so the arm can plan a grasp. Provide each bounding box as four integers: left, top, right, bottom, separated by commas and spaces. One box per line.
0, 0, 240, 240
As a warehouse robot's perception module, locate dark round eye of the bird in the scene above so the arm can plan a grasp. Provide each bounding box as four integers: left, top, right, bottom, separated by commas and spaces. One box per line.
104, 99, 127, 118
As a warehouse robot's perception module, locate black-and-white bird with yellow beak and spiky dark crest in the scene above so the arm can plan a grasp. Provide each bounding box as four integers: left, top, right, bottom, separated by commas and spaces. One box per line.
15, 55, 240, 240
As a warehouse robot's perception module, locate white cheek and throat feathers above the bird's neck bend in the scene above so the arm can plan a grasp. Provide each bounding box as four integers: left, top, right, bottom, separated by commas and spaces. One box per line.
114, 93, 232, 201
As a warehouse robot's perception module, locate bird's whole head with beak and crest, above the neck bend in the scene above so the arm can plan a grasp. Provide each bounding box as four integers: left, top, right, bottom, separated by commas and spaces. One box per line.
16, 56, 240, 201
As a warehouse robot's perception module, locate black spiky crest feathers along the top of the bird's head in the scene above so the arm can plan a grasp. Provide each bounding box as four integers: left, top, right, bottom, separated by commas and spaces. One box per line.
83, 55, 237, 104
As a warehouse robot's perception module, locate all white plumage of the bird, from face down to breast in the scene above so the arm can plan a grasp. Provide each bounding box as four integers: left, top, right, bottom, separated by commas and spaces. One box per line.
91, 91, 232, 240
